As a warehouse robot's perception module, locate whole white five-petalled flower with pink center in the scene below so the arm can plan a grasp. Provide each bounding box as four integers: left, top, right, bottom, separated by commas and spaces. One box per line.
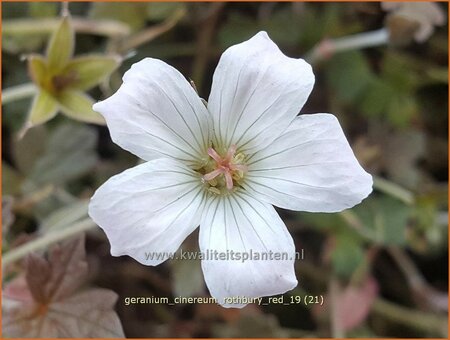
89, 32, 372, 307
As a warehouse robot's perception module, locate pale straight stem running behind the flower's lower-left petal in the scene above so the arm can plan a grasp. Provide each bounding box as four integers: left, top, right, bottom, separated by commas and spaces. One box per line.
2, 218, 97, 268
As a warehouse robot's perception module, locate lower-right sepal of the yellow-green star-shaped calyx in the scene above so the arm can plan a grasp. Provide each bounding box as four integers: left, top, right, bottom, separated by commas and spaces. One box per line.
58, 90, 105, 125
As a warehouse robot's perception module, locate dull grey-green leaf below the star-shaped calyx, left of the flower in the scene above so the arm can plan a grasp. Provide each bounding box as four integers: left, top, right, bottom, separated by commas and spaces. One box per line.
24, 123, 97, 187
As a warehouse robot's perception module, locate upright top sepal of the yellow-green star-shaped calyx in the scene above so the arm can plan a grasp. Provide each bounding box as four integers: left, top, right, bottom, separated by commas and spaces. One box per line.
46, 16, 75, 74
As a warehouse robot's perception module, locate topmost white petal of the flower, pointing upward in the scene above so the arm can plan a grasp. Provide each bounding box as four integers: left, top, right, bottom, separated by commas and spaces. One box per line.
208, 32, 314, 151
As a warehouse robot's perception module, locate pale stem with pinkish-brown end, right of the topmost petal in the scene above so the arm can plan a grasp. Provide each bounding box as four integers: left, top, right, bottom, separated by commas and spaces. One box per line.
305, 28, 389, 63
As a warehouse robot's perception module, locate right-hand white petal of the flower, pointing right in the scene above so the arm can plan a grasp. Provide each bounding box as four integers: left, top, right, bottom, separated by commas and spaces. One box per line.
245, 114, 372, 212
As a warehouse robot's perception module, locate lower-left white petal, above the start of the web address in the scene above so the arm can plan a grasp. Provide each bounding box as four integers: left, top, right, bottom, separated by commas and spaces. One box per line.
89, 158, 204, 266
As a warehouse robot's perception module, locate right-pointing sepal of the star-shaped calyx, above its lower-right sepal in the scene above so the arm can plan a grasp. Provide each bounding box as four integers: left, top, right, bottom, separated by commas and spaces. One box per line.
63, 55, 122, 90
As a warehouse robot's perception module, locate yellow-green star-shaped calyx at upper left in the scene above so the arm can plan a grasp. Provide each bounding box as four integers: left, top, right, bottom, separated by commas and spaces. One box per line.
25, 15, 122, 130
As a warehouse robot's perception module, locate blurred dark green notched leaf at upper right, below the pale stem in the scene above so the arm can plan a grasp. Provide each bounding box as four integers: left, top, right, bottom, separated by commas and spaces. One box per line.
327, 51, 423, 127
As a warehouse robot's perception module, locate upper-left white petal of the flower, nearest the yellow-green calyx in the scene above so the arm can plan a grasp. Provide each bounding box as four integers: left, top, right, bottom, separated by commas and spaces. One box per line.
94, 58, 210, 163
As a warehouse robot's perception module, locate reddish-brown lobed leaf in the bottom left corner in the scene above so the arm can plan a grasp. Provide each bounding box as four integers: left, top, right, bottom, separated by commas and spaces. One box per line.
2, 237, 124, 338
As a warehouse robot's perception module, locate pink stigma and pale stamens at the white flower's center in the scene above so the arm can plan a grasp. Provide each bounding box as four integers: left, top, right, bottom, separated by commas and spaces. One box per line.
203, 145, 247, 194
